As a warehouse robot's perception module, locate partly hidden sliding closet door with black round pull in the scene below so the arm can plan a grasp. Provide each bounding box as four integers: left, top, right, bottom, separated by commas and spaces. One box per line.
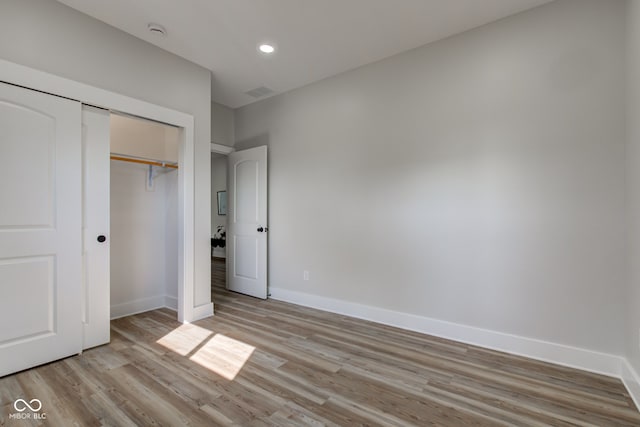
82, 105, 111, 349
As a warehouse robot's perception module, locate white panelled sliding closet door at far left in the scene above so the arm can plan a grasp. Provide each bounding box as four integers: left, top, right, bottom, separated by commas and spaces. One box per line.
0, 83, 82, 376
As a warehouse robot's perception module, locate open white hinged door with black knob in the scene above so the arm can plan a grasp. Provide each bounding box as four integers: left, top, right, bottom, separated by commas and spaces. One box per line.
227, 146, 268, 299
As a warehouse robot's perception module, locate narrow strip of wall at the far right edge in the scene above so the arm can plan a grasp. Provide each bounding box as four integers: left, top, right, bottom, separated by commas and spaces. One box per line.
626, 0, 640, 397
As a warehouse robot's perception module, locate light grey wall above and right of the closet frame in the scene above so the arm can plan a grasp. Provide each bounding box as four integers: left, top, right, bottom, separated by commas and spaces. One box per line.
0, 0, 211, 312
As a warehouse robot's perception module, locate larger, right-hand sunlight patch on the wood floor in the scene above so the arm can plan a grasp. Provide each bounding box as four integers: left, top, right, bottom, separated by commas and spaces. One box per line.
189, 334, 256, 380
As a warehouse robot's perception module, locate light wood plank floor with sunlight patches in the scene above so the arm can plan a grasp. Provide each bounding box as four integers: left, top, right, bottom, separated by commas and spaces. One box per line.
0, 262, 640, 426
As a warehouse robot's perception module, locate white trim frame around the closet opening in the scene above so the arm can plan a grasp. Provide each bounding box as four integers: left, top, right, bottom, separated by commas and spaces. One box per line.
0, 59, 213, 322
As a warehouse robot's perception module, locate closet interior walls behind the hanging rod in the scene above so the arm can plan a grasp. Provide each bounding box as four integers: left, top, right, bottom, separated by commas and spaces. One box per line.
110, 114, 180, 318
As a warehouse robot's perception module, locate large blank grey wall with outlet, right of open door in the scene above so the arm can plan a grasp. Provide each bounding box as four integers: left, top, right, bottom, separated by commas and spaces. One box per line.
235, 0, 626, 355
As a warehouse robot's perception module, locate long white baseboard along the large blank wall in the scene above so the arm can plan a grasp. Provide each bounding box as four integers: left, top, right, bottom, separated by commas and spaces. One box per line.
269, 287, 624, 378
